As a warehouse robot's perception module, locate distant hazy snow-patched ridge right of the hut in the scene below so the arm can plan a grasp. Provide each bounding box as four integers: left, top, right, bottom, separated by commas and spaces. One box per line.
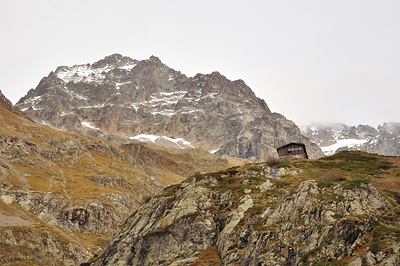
301, 122, 400, 156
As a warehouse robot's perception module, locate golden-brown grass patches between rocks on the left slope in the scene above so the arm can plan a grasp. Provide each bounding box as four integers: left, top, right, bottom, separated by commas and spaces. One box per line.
0, 107, 238, 265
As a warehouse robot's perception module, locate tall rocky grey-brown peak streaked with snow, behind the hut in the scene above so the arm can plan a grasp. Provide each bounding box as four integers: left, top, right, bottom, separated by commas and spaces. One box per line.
16, 54, 323, 161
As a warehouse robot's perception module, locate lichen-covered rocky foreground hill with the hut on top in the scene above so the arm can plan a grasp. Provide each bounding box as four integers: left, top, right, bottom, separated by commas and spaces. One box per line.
83, 152, 400, 266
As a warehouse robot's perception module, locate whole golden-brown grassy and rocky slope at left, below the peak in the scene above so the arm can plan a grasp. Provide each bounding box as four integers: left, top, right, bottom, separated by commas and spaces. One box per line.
0, 90, 231, 265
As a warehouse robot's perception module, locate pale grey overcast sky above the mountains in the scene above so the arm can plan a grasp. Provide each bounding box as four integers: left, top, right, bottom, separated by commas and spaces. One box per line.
0, 0, 400, 126
